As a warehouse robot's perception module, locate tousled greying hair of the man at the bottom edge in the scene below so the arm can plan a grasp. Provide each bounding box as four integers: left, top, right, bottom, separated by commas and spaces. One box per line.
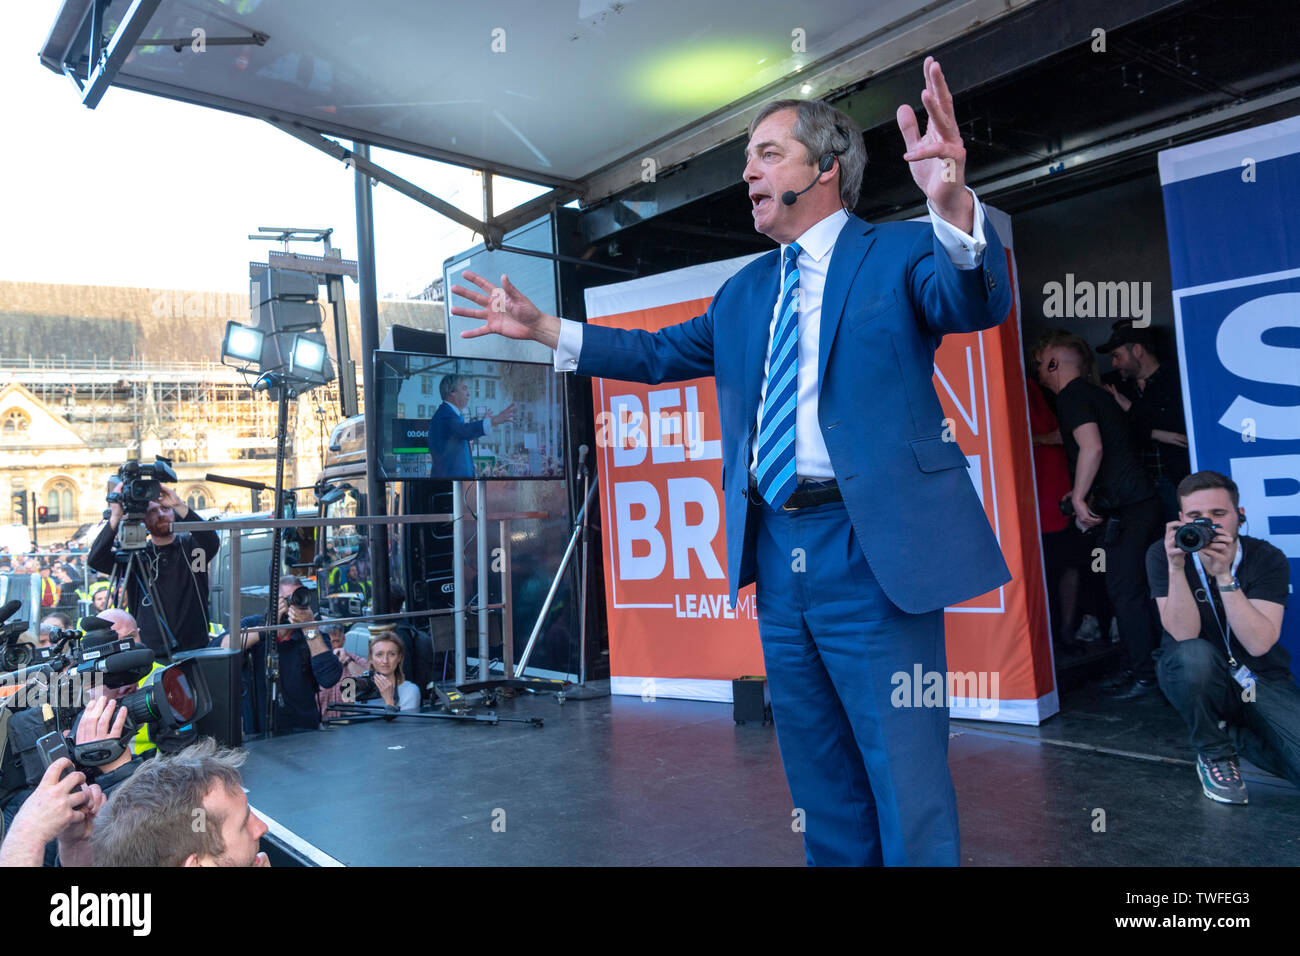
91, 737, 247, 866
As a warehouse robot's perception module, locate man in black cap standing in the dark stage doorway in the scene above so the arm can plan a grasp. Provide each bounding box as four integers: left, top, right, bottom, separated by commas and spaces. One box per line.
1097, 319, 1192, 522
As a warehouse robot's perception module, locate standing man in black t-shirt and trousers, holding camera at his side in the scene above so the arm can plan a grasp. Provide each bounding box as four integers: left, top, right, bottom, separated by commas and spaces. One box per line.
1034, 330, 1160, 700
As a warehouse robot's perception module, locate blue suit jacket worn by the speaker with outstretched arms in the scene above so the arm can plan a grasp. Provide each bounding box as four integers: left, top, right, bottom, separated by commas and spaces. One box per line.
576, 216, 1011, 614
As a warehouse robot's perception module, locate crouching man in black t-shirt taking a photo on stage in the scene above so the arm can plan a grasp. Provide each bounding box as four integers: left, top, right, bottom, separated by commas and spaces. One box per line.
1147, 471, 1300, 804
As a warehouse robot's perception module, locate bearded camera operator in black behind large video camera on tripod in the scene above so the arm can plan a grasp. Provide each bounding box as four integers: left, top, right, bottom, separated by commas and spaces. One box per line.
86, 484, 221, 659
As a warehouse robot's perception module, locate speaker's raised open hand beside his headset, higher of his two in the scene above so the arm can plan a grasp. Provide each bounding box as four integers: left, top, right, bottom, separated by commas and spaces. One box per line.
894, 56, 975, 233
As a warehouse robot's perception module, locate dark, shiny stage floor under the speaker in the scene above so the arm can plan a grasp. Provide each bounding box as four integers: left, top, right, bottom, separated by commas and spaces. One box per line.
244, 684, 1300, 866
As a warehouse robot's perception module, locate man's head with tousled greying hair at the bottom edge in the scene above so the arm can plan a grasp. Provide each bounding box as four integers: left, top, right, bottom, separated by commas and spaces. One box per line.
91, 737, 270, 866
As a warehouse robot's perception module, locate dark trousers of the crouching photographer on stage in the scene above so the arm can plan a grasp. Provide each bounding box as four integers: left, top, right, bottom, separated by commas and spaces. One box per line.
1156, 637, 1300, 787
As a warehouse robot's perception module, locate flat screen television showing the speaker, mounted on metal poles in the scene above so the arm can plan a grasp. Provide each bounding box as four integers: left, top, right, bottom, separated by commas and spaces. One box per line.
374, 351, 564, 481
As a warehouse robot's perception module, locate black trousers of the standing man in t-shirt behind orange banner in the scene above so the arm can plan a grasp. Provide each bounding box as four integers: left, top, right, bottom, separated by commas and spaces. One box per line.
1100, 497, 1161, 680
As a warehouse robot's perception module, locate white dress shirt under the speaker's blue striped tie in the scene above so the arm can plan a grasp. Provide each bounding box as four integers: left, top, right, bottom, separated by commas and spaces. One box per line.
555, 186, 987, 480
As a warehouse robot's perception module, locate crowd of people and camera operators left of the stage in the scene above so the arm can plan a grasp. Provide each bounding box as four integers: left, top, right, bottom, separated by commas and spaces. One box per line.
0, 485, 433, 866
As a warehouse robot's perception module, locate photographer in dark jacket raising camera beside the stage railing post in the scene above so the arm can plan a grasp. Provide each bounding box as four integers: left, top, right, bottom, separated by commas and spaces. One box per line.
212, 575, 343, 734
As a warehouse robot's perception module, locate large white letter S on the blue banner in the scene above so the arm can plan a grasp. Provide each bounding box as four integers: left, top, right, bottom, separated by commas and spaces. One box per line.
1214, 293, 1300, 442
